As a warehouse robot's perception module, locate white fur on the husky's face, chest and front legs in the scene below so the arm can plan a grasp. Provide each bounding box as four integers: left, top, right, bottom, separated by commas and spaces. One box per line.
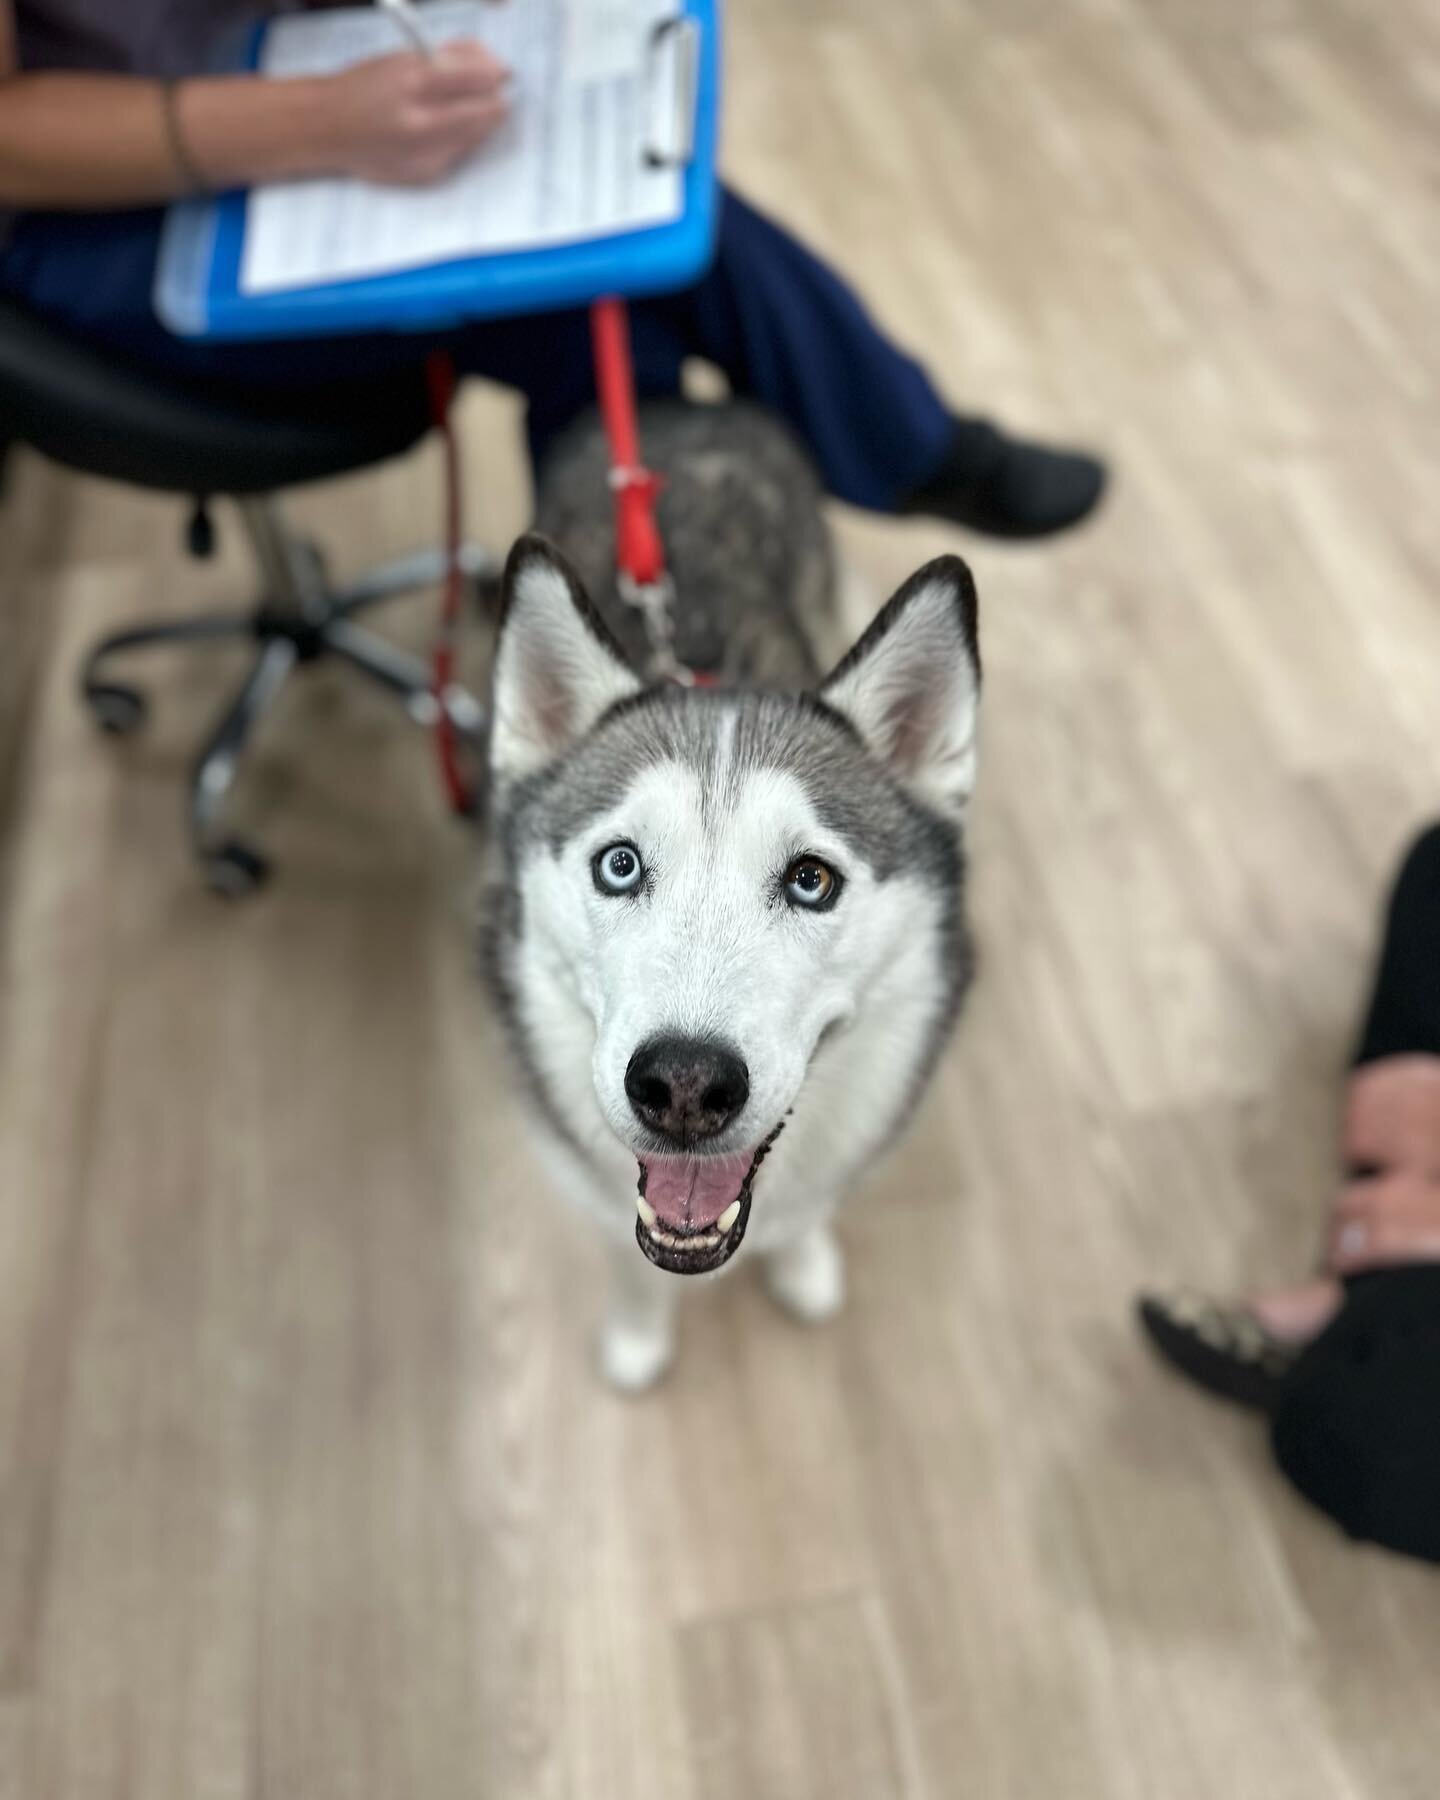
515, 738, 943, 1391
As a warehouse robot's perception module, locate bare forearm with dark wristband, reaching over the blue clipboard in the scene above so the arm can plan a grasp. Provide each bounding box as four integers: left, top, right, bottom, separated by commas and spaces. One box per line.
0, 74, 337, 211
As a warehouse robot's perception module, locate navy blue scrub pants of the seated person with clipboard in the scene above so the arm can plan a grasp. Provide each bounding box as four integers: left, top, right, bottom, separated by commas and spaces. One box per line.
0, 193, 952, 511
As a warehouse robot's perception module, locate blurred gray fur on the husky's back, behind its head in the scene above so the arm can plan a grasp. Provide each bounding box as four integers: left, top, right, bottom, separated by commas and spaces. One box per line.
535, 400, 835, 689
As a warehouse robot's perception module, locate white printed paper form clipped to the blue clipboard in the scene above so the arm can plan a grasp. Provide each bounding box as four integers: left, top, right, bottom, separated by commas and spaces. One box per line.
239, 0, 684, 293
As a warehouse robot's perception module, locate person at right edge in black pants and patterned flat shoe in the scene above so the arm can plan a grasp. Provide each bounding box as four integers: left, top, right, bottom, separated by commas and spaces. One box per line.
1141, 824, 1440, 1561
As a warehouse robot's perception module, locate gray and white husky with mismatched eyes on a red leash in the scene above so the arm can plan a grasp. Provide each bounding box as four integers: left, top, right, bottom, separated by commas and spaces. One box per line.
486, 405, 979, 1390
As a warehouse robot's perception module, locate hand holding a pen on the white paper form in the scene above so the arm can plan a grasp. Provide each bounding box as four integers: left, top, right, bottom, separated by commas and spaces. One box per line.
322, 40, 509, 187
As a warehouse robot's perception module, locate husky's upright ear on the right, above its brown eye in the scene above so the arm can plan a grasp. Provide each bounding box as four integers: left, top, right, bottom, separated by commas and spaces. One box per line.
821, 556, 979, 819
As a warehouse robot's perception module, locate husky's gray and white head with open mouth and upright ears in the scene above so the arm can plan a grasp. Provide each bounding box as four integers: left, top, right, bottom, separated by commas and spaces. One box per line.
491, 538, 979, 1273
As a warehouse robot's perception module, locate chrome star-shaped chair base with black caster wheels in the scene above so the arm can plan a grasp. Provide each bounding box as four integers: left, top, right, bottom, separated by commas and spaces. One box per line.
79, 500, 495, 898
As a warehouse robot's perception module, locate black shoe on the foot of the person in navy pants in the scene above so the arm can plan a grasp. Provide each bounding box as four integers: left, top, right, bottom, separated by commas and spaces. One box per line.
900, 419, 1105, 538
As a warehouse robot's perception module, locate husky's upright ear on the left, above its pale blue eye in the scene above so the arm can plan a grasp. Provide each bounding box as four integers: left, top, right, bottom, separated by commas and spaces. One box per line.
490, 533, 641, 781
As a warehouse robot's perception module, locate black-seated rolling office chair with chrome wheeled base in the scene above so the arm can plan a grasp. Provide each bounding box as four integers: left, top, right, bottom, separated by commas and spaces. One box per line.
0, 299, 495, 896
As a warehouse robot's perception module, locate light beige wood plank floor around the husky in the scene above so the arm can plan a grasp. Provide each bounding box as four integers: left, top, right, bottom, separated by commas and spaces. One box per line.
0, 0, 1440, 1800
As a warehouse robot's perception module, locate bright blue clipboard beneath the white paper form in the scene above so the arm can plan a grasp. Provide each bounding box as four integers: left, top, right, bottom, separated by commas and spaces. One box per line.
155, 0, 720, 340
